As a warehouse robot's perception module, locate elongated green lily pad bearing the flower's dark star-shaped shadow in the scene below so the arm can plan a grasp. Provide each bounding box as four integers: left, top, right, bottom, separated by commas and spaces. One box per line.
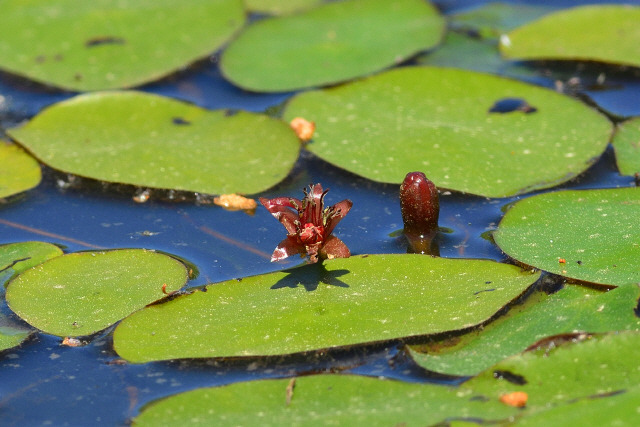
114, 255, 538, 363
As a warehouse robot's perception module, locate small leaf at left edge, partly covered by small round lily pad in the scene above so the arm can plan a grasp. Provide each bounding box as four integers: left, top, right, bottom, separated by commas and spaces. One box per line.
0, 242, 62, 290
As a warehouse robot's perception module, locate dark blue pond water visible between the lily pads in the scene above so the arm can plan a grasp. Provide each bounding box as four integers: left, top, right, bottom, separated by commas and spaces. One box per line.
0, 0, 640, 426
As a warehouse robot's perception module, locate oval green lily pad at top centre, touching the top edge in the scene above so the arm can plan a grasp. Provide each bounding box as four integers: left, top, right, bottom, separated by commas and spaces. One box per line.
220, 0, 445, 92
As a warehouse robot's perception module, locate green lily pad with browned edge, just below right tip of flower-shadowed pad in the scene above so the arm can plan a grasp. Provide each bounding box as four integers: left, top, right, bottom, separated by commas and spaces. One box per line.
409, 285, 640, 375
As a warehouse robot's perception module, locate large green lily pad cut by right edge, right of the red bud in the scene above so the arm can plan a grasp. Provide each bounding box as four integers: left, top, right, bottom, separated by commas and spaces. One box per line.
494, 188, 640, 286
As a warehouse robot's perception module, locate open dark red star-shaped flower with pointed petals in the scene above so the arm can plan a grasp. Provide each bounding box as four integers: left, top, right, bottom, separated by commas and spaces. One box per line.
260, 184, 353, 263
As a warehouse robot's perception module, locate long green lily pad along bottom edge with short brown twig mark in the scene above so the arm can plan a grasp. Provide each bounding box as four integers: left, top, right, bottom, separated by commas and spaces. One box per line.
134, 375, 518, 426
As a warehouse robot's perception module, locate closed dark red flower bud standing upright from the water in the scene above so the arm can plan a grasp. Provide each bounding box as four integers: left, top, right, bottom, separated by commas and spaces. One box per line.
400, 172, 440, 253
